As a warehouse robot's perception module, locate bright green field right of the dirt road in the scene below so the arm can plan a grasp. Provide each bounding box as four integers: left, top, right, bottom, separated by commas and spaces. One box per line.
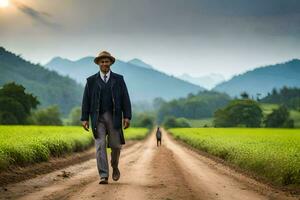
169, 128, 300, 186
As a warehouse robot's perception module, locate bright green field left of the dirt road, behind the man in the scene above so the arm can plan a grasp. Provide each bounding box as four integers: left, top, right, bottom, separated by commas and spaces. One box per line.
0, 126, 149, 170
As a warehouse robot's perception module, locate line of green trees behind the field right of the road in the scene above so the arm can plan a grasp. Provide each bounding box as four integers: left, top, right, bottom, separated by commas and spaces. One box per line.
158, 87, 300, 128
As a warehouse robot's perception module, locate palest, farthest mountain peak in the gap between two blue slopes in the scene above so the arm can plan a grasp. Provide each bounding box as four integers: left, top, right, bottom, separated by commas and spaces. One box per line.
178, 73, 225, 89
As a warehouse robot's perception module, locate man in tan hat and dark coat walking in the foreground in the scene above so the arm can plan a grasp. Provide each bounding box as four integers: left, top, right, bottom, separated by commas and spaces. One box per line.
81, 51, 131, 184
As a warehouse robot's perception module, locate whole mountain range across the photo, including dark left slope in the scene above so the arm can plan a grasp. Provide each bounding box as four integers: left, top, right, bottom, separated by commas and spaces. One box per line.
0, 47, 300, 115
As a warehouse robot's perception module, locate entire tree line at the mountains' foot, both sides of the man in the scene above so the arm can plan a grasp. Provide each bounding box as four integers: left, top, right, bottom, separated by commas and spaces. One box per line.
0, 82, 300, 128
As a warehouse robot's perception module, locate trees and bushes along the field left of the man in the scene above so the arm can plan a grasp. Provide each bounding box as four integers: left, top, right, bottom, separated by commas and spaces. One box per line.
0, 82, 80, 125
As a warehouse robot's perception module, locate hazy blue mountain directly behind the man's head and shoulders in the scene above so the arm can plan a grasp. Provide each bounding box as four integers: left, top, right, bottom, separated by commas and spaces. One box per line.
45, 57, 204, 102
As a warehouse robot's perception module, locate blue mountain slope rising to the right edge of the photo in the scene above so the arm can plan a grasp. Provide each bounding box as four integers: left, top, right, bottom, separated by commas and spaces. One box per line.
213, 59, 300, 97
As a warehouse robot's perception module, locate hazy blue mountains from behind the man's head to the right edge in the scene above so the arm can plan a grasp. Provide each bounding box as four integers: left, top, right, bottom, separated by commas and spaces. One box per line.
46, 54, 300, 101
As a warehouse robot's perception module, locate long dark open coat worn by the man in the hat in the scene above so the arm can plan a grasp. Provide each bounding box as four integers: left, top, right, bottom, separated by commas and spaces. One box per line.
81, 71, 131, 144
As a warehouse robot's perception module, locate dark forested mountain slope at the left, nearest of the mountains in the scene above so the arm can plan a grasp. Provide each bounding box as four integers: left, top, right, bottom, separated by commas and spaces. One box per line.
0, 47, 83, 116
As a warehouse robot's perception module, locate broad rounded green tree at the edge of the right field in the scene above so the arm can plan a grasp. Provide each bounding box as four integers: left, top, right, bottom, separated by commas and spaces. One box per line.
214, 99, 263, 127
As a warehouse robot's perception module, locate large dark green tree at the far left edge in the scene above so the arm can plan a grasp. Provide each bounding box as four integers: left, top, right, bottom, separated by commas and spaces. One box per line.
0, 82, 40, 124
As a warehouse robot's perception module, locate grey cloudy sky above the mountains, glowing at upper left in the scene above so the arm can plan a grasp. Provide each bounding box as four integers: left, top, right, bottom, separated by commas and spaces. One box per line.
0, 0, 300, 78
